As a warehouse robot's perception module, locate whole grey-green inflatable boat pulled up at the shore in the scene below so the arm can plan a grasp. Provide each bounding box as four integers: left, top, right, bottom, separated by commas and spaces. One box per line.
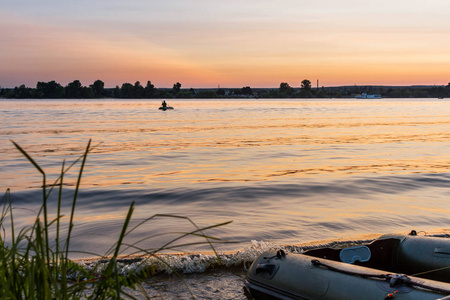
245, 233, 450, 300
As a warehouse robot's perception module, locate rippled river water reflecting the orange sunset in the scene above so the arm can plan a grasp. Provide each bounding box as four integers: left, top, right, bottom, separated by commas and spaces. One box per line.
0, 99, 450, 296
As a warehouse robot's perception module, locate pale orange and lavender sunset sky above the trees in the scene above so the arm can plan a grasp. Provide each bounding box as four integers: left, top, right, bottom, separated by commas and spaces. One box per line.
0, 0, 450, 88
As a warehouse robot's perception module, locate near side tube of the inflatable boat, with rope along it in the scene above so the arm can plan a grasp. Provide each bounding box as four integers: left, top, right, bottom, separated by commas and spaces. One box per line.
246, 252, 450, 300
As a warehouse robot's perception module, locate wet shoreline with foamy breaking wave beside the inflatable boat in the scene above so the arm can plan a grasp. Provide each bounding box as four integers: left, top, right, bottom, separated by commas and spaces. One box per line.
70, 229, 450, 300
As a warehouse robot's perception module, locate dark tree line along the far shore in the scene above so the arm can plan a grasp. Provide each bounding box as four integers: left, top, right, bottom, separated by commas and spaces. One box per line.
0, 79, 450, 99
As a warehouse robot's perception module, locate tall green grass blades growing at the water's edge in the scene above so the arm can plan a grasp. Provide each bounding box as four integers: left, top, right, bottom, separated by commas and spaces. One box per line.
0, 141, 230, 299
